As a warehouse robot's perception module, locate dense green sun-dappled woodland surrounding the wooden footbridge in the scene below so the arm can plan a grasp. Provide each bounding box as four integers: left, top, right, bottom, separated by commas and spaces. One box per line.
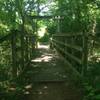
0, 0, 100, 100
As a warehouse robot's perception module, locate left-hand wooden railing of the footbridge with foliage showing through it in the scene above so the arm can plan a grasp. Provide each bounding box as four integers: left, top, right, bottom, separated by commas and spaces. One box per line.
0, 30, 35, 78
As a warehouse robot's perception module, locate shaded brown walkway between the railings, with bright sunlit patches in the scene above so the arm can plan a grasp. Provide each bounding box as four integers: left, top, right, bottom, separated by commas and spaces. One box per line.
16, 45, 83, 100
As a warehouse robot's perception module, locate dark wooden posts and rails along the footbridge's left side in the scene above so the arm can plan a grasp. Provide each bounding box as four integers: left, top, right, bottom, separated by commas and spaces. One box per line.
0, 31, 35, 78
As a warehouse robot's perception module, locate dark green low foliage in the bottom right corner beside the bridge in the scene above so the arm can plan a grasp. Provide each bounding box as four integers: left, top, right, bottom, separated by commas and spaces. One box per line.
84, 61, 100, 100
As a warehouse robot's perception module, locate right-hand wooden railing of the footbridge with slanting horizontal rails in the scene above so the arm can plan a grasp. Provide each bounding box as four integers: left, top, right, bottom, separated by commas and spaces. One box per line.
52, 34, 88, 75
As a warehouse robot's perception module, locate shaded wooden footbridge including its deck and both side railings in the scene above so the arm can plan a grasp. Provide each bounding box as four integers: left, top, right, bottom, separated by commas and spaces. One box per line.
0, 27, 88, 100
